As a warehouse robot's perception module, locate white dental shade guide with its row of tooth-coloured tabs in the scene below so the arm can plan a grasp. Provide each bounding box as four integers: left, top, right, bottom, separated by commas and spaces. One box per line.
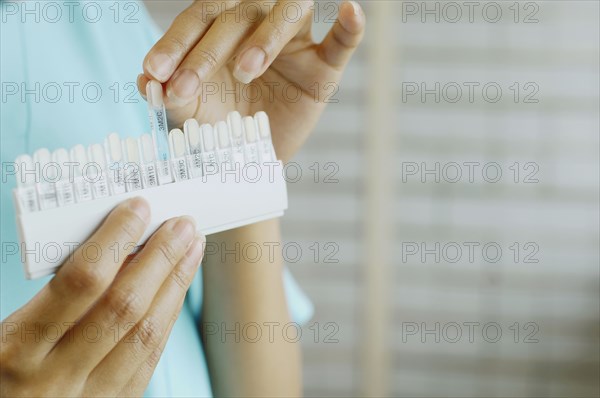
13, 112, 288, 279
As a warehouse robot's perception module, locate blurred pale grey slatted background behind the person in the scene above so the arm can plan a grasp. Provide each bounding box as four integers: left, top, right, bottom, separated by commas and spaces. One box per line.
147, 0, 600, 396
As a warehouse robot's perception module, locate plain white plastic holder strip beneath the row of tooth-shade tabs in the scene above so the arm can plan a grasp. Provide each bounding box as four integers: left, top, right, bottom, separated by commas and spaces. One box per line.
14, 162, 287, 279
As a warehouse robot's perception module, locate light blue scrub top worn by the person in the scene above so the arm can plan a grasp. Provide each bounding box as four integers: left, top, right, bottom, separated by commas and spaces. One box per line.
0, 0, 313, 397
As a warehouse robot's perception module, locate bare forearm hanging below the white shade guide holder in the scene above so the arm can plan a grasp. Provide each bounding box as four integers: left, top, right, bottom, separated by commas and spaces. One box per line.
202, 220, 301, 396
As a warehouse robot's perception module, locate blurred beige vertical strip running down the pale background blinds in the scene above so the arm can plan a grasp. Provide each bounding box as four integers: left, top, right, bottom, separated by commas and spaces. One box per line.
360, 1, 399, 397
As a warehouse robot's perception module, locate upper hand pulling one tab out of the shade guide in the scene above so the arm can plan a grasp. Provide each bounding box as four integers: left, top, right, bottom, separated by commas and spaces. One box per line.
138, 0, 365, 161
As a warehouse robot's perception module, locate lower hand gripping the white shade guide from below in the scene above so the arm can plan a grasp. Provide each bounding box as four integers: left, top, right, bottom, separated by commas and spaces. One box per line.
0, 198, 204, 397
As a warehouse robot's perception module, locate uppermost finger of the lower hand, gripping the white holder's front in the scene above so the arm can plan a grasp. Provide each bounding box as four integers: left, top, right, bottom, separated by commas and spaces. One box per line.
6, 198, 150, 357
